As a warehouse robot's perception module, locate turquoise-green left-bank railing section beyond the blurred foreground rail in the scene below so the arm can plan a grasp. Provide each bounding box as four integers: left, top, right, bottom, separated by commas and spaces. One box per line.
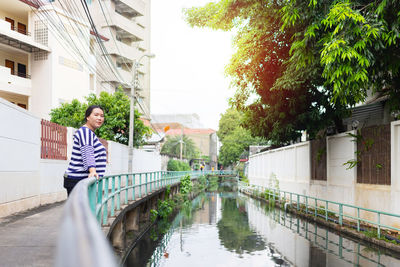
88, 171, 235, 225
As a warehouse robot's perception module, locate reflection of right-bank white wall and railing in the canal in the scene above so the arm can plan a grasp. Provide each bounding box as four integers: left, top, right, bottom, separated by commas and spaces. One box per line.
246, 197, 400, 266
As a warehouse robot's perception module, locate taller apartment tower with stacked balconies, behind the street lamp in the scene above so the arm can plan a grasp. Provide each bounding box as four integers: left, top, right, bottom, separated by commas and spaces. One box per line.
90, 0, 150, 119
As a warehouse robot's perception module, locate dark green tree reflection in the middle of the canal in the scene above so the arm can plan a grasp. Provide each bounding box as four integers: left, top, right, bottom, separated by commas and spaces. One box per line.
217, 198, 265, 254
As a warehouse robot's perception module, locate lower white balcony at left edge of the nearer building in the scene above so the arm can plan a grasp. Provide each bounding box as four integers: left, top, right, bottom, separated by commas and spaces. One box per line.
0, 66, 32, 96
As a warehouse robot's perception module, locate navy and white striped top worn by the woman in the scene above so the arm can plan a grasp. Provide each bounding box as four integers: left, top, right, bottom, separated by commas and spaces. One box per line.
67, 126, 107, 179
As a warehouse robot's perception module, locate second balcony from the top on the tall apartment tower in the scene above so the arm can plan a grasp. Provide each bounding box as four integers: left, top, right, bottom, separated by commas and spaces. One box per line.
102, 11, 145, 41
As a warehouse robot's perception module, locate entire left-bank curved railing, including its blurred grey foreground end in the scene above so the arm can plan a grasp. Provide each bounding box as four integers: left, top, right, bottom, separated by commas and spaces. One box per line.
55, 171, 234, 267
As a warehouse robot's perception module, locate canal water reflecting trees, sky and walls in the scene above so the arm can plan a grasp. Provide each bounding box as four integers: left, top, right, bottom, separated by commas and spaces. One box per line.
126, 184, 400, 267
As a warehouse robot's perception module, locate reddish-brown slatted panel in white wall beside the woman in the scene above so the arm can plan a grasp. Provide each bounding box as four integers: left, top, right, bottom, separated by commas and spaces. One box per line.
40, 119, 67, 160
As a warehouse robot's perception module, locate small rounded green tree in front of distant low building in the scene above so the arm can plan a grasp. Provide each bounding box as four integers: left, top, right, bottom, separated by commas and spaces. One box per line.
161, 135, 200, 159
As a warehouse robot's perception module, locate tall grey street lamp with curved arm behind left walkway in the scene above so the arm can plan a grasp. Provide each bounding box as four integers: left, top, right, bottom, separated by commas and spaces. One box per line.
128, 54, 156, 173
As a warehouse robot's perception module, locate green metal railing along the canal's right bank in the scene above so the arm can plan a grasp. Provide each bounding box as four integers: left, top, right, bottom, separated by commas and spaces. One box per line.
239, 182, 400, 238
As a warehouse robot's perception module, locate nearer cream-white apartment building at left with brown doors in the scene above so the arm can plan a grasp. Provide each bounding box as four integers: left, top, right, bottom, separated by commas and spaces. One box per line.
0, 0, 96, 119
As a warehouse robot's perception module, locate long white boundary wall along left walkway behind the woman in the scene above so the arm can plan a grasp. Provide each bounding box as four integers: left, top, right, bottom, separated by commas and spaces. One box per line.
0, 98, 161, 217
